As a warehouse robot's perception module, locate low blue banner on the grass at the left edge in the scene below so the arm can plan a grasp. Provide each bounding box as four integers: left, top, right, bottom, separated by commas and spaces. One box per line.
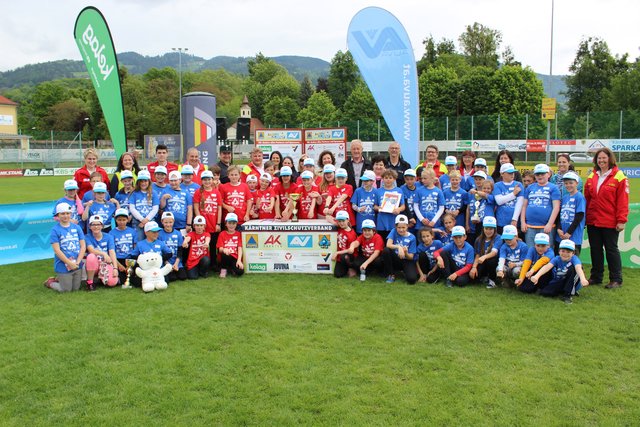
0, 202, 55, 265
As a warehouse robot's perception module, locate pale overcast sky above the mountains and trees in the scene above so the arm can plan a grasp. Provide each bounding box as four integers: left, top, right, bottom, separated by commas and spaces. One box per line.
0, 0, 640, 75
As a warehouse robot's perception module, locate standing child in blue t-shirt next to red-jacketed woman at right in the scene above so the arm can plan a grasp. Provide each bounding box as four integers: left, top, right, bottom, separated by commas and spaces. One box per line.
556, 172, 587, 255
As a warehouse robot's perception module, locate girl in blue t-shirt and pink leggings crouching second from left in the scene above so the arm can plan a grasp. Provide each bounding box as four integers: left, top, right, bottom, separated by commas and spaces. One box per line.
86, 215, 119, 291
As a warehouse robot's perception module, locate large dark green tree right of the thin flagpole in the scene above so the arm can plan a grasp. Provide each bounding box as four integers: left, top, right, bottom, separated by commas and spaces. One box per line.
565, 37, 629, 112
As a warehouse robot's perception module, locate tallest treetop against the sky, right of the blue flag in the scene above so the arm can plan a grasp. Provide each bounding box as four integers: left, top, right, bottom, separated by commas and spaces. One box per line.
458, 22, 502, 69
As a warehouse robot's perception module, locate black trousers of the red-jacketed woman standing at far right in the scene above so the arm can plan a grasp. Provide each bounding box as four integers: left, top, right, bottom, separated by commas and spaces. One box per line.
587, 225, 622, 283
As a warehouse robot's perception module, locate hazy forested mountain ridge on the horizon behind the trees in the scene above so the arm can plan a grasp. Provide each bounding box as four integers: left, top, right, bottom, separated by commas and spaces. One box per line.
0, 52, 566, 104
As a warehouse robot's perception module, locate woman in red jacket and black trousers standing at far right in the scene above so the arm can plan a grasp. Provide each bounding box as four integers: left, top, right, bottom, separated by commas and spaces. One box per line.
584, 148, 629, 289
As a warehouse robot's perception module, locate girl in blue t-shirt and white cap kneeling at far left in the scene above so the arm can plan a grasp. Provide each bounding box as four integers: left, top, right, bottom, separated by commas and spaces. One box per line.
48, 203, 87, 292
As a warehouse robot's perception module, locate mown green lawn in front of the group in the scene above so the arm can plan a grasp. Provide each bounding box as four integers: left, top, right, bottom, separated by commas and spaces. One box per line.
0, 261, 640, 426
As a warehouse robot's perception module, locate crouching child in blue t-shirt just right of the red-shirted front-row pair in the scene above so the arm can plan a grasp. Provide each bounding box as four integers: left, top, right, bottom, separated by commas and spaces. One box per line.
382, 215, 418, 285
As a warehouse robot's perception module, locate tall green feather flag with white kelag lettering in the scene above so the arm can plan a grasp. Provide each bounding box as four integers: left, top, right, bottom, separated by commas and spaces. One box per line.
73, 6, 127, 158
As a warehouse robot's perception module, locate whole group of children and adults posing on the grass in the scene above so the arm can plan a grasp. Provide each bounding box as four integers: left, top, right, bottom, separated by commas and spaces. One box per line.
50, 140, 628, 301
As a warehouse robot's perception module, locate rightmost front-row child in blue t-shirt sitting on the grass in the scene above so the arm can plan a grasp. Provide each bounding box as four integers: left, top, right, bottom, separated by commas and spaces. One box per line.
531, 239, 589, 304
